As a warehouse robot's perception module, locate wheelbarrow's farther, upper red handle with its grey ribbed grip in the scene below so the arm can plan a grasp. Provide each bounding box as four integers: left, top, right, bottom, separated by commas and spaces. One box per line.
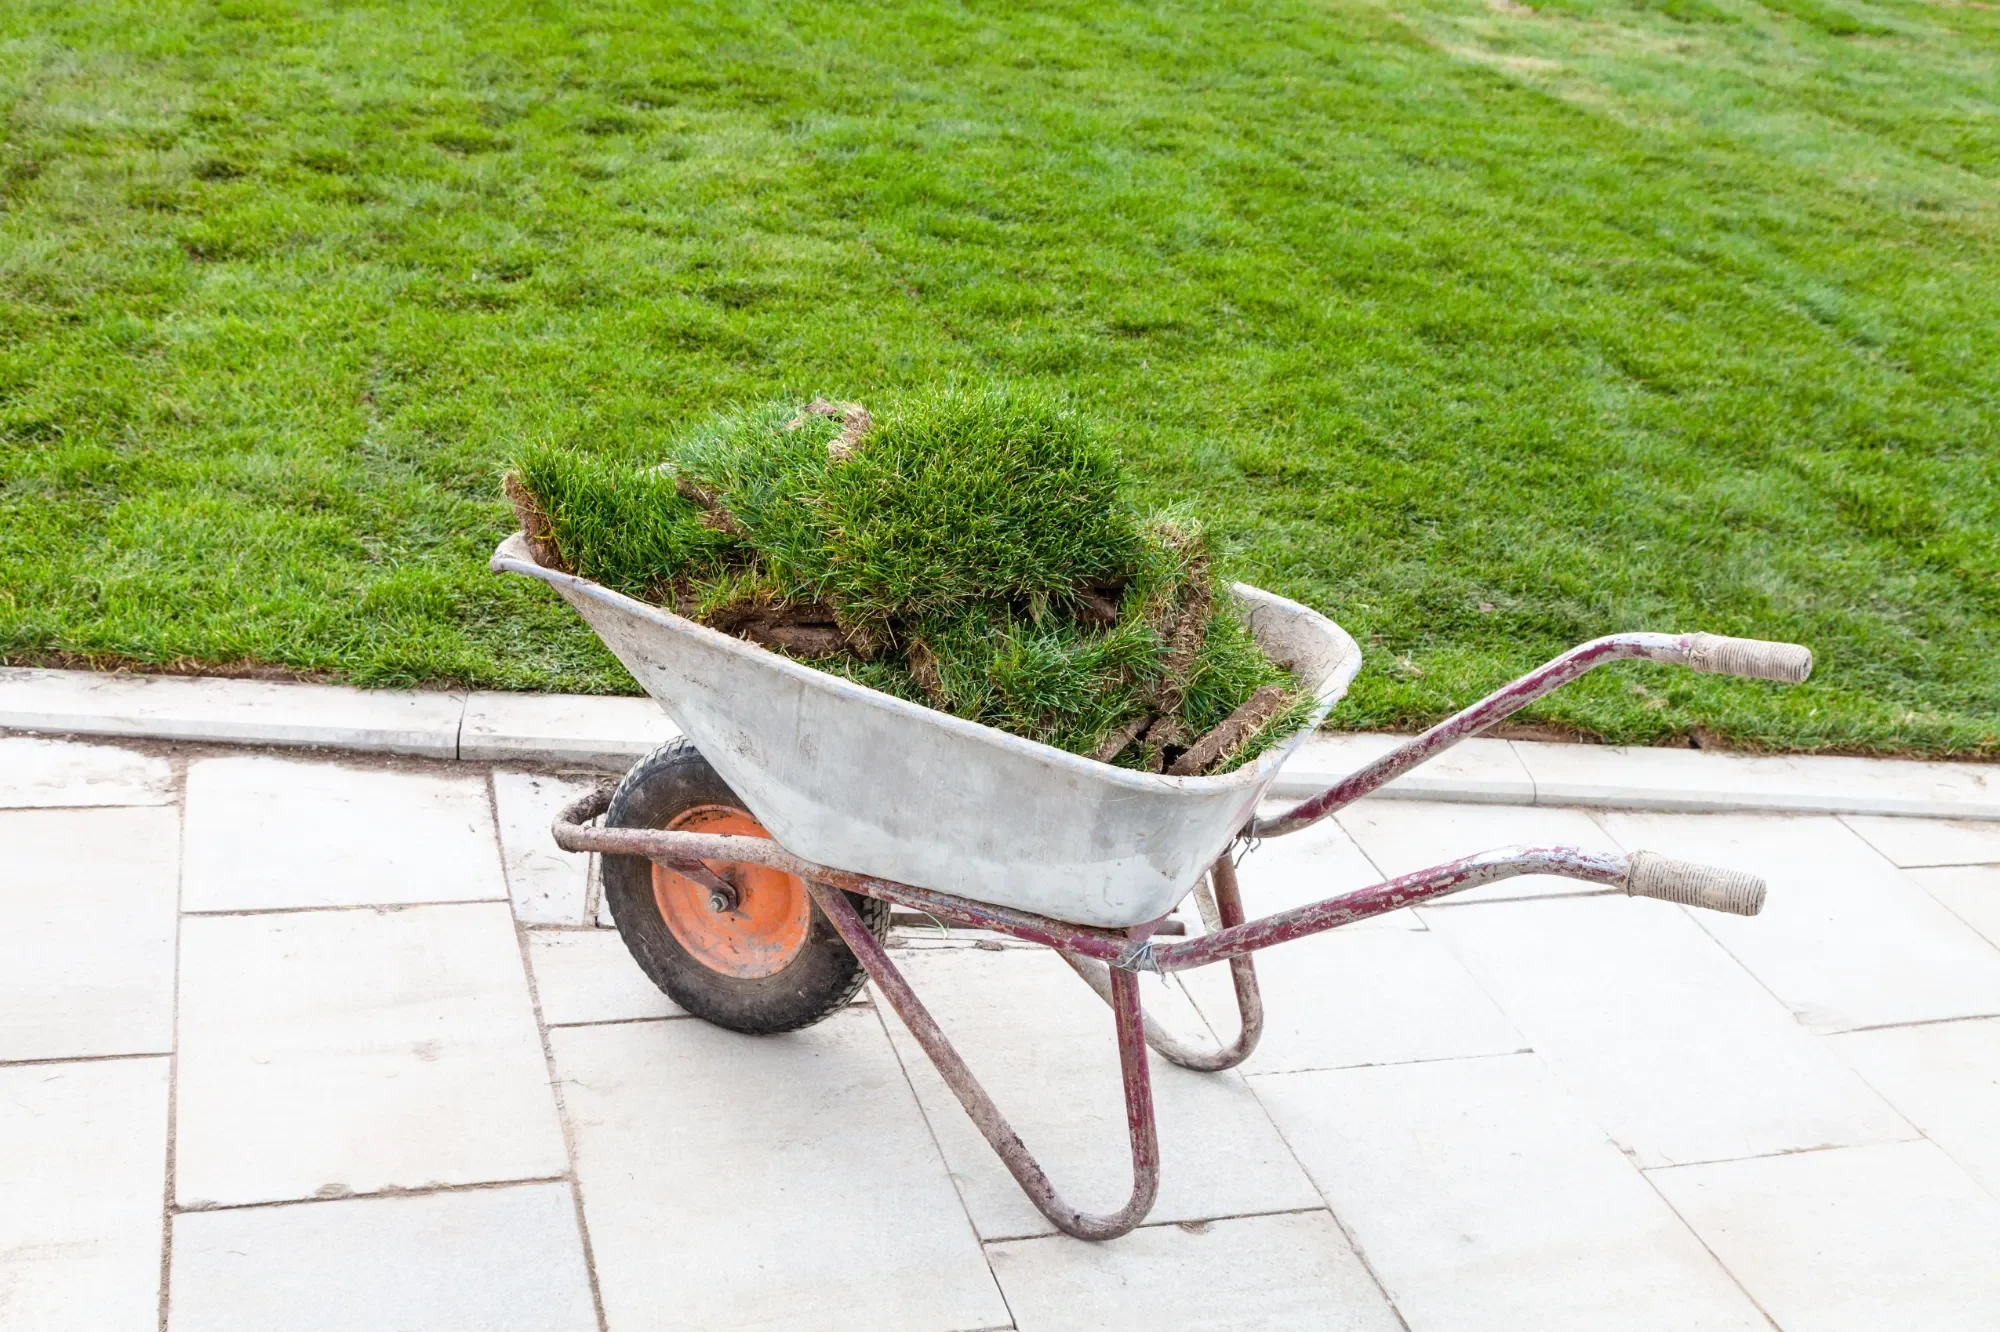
1248, 634, 1812, 838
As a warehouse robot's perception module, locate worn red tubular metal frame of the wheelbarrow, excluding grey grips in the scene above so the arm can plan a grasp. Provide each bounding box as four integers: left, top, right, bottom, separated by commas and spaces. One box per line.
554, 634, 1800, 1240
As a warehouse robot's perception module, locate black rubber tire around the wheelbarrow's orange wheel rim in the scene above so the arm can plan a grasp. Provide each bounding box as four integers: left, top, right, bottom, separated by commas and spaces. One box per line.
604, 740, 890, 1036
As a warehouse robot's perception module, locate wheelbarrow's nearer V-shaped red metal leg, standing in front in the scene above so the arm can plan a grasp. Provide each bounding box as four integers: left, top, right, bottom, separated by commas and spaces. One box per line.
806, 878, 1160, 1240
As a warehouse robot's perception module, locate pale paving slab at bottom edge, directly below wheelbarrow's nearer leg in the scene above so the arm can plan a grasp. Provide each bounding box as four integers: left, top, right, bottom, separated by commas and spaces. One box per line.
986, 1212, 1402, 1332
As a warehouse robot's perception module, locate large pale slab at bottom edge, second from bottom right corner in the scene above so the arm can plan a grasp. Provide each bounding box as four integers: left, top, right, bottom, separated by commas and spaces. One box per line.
1250, 1054, 1768, 1332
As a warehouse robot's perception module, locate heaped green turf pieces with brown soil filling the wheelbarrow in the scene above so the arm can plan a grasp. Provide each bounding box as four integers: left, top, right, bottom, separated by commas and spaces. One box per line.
506, 390, 1312, 776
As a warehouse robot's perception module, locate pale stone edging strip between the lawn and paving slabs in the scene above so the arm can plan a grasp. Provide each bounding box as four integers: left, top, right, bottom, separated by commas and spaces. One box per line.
0, 666, 2000, 820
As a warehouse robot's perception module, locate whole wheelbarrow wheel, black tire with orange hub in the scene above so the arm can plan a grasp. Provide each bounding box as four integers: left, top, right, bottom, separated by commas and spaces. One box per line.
604, 740, 888, 1034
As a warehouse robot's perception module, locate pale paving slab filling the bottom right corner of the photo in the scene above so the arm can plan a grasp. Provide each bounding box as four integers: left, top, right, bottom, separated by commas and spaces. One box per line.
1652, 1142, 2000, 1332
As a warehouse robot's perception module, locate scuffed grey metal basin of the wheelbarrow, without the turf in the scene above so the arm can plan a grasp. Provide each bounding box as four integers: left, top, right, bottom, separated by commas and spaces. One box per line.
492, 534, 1362, 928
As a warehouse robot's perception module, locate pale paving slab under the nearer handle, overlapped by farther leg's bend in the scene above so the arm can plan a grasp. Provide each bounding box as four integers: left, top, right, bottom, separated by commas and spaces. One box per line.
1180, 928, 1528, 1072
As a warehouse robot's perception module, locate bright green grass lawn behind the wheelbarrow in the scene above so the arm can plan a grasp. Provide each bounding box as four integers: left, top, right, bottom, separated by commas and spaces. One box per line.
0, 0, 2000, 756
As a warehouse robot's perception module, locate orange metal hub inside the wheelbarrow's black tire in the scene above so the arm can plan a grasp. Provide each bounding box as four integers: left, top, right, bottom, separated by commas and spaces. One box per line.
652, 804, 812, 980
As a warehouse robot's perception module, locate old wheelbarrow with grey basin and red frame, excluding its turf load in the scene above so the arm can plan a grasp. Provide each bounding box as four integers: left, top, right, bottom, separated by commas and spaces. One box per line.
492, 534, 1812, 1240
